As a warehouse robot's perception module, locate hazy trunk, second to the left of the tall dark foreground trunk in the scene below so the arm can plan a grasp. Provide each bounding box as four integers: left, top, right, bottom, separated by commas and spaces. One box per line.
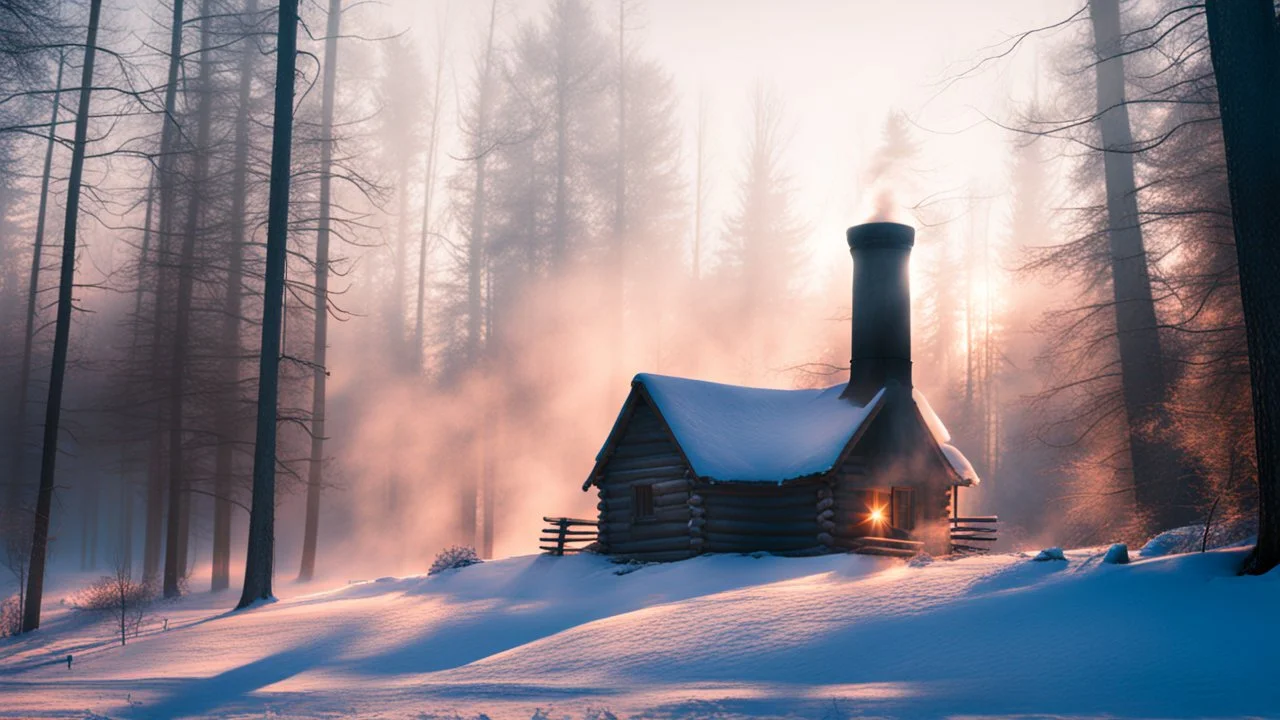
164, 0, 212, 597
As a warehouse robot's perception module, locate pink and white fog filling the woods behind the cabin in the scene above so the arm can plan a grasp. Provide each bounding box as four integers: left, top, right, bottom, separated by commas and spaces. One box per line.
0, 0, 1249, 597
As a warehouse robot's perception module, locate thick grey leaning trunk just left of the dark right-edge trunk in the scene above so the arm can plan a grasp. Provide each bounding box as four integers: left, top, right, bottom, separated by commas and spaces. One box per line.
1089, 0, 1201, 530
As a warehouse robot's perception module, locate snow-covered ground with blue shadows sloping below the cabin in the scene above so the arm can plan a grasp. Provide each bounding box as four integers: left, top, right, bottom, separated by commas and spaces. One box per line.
0, 548, 1280, 720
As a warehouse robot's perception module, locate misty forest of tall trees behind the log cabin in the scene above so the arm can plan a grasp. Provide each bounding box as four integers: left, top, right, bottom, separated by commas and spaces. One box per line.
0, 0, 1280, 632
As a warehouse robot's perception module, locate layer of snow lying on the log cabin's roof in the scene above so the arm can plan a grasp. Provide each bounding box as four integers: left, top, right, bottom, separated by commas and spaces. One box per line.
596, 373, 978, 483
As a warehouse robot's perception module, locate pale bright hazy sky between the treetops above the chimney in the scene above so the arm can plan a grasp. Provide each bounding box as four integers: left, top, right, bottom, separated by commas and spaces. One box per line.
392, 0, 1079, 278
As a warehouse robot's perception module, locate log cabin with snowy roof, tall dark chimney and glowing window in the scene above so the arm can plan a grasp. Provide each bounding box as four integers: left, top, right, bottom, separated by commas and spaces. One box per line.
582, 223, 979, 561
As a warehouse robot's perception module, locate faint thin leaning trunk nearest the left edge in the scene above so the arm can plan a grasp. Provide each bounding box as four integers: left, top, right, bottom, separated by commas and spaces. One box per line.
6, 53, 67, 510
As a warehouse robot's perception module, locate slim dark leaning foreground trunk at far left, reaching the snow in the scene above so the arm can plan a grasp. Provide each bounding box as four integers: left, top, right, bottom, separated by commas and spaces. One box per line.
22, 0, 102, 633
